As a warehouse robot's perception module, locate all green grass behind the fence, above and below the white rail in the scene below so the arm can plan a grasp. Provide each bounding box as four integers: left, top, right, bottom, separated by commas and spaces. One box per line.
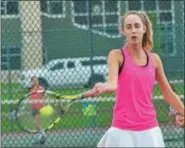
1, 84, 184, 133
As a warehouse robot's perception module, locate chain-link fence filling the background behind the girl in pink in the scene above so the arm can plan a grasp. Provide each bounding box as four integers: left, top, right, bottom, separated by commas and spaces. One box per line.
1, 0, 184, 147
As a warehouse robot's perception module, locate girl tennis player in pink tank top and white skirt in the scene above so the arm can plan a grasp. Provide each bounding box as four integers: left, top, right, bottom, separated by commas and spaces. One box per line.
87, 11, 184, 147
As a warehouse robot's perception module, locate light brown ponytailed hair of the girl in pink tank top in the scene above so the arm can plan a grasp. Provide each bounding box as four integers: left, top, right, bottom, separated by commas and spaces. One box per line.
121, 11, 153, 50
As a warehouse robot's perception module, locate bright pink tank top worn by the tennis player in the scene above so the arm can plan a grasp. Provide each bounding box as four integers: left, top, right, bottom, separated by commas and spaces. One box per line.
112, 47, 158, 131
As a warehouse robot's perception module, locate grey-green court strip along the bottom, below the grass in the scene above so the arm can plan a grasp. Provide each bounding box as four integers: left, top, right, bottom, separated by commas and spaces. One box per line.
1, 125, 184, 147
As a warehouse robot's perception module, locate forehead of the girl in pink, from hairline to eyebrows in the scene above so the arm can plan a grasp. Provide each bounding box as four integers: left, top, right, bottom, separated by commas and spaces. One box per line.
124, 14, 142, 25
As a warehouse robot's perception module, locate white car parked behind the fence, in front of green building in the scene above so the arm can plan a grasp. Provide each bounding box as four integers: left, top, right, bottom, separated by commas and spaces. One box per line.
20, 56, 108, 88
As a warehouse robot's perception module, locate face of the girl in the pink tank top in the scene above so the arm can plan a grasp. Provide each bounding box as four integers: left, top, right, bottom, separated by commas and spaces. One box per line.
122, 14, 146, 45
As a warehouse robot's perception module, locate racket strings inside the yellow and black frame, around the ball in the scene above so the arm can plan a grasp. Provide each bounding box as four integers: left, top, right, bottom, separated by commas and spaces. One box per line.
16, 92, 65, 133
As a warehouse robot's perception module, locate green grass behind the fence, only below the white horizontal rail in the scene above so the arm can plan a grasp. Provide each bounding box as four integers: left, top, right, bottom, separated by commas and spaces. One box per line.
1, 99, 184, 133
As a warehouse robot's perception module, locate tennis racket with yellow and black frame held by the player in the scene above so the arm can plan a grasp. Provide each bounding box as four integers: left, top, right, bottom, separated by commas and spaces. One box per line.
15, 90, 95, 133
